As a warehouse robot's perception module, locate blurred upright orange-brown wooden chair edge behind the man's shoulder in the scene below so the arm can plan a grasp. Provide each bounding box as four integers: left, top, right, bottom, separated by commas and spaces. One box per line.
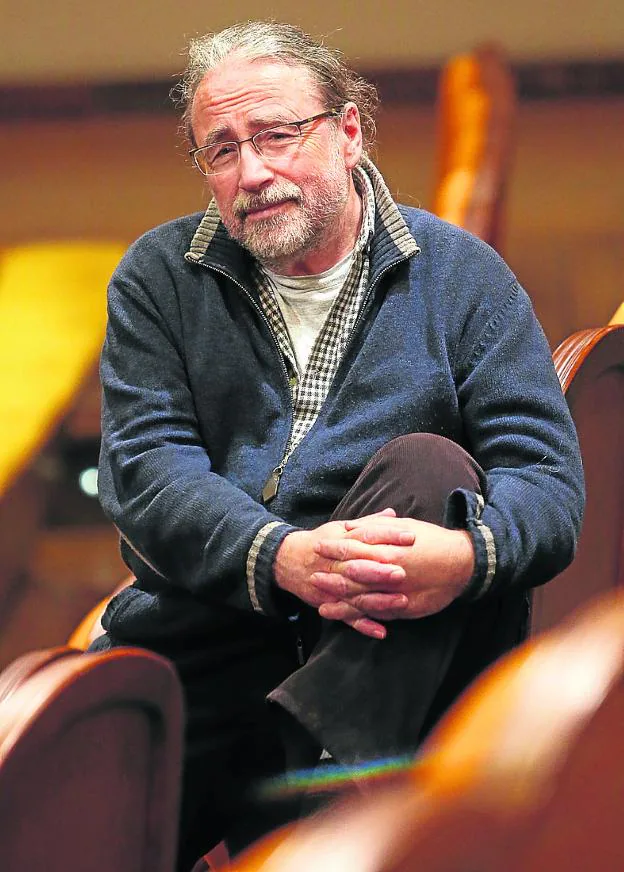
432, 45, 516, 249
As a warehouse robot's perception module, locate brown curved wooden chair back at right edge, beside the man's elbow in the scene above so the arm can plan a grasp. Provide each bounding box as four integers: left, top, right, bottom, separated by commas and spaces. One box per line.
532, 325, 624, 632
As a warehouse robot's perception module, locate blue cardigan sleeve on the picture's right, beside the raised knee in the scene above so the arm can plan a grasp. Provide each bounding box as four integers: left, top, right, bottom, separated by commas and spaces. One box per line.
448, 280, 585, 598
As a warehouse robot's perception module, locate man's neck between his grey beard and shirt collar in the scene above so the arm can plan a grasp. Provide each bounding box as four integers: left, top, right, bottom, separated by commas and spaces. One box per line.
264, 179, 363, 276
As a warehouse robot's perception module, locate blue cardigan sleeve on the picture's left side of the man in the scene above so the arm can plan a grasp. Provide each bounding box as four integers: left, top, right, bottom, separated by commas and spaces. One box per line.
98, 246, 296, 616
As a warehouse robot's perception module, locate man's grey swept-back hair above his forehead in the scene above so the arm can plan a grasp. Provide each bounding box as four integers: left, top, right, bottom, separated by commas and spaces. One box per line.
172, 21, 378, 149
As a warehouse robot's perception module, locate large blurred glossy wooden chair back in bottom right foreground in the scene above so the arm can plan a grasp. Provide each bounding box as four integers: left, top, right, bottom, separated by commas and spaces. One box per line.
224, 592, 624, 872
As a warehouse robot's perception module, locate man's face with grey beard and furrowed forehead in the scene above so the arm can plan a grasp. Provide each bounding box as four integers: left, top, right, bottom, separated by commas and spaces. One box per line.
192, 56, 361, 267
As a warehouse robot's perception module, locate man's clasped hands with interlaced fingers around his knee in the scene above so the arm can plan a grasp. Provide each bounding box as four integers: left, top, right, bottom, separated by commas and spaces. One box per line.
274, 509, 474, 639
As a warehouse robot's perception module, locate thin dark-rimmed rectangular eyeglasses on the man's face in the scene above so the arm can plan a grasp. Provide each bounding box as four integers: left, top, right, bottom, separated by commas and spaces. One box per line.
189, 109, 341, 176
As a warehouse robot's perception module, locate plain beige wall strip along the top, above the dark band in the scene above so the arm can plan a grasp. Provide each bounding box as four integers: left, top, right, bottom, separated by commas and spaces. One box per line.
0, 0, 624, 82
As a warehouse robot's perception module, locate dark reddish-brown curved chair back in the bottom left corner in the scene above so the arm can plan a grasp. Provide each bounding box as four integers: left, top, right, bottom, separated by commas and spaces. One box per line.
0, 649, 182, 872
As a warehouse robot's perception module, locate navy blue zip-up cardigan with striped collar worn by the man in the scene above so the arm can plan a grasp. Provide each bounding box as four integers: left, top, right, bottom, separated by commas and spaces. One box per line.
99, 201, 584, 640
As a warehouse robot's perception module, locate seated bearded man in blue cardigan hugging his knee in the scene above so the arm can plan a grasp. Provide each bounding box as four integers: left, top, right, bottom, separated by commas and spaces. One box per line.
97, 22, 583, 870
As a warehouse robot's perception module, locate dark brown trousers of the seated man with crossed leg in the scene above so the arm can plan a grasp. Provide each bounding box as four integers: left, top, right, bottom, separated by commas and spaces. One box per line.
95, 434, 526, 872
